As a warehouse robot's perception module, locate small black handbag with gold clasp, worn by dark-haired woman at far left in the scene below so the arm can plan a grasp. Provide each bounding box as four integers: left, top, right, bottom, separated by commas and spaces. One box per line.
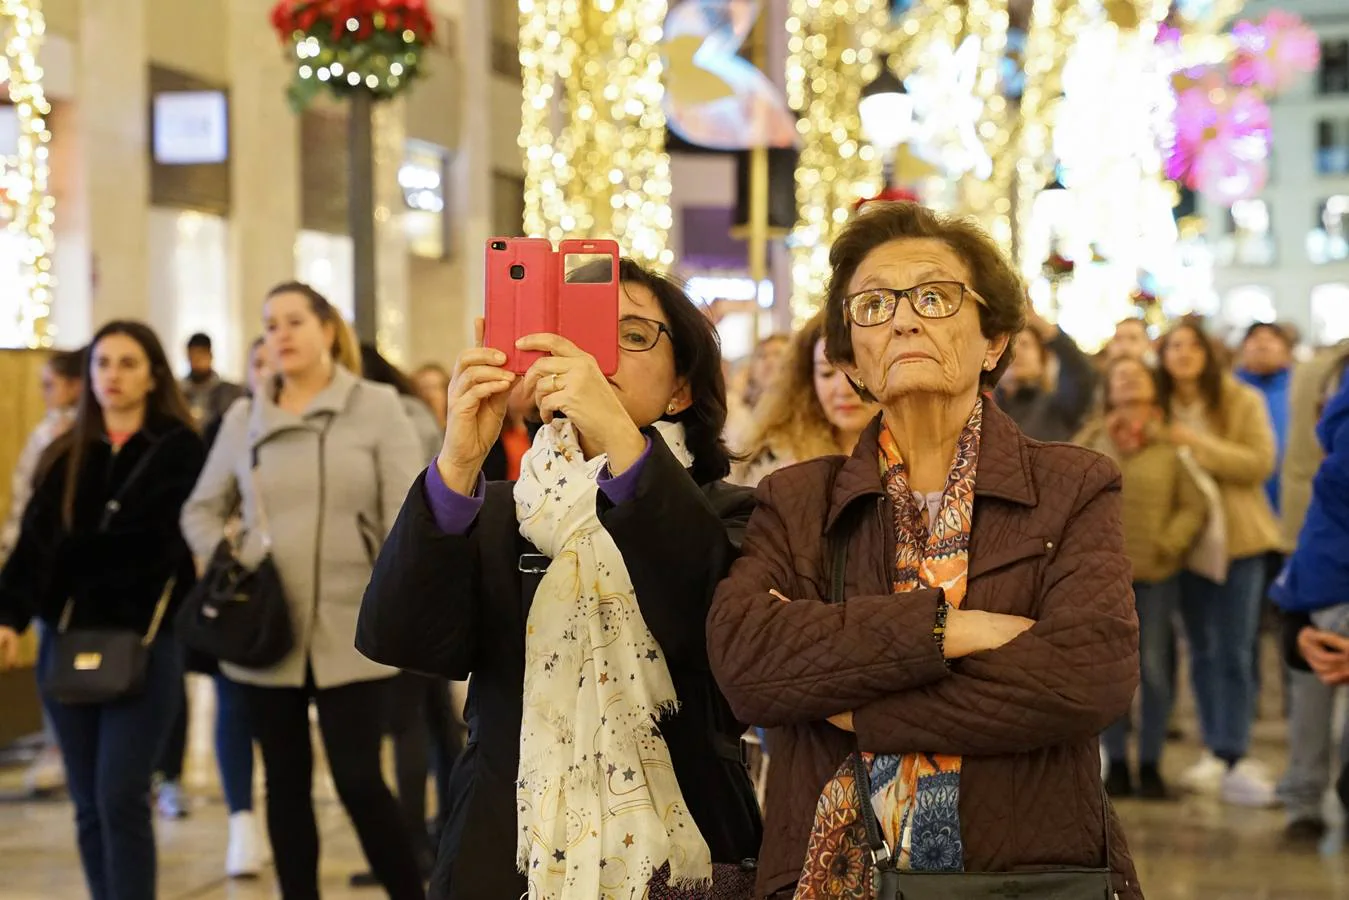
42, 444, 177, 706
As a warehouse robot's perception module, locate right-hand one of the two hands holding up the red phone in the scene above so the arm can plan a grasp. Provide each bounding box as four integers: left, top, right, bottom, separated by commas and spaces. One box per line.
515, 335, 646, 475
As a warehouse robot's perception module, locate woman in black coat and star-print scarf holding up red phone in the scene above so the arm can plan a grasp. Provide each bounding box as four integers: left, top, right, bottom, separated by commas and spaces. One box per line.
356, 260, 759, 900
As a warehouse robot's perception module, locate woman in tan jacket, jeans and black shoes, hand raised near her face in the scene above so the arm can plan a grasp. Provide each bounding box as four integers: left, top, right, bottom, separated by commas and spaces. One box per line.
1075, 356, 1207, 800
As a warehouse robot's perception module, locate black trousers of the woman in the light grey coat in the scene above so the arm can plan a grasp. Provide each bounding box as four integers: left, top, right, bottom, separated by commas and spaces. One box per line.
244, 676, 426, 900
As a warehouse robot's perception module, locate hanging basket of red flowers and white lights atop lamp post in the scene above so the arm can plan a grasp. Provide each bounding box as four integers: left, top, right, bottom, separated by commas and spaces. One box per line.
271, 0, 436, 111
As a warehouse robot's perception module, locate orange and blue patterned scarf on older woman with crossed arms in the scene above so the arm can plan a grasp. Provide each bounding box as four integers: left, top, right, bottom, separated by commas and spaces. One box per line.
796, 398, 983, 900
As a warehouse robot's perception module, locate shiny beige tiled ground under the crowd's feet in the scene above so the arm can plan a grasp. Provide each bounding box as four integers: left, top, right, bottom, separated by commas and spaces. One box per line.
0, 658, 1349, 900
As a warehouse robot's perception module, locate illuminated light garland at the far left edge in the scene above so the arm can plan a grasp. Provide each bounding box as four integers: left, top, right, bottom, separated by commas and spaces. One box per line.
0, 0, 55, 348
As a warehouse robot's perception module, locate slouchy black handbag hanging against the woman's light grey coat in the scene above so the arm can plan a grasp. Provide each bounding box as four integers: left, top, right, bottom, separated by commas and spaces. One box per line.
174, 455, 295, 669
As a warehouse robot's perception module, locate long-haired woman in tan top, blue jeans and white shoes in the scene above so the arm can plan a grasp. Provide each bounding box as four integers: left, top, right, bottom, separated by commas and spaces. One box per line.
1159, 321, 1280, 807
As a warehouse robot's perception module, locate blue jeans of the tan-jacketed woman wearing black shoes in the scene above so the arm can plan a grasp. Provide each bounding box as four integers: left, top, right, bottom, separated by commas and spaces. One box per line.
1101, 578, 1180, 765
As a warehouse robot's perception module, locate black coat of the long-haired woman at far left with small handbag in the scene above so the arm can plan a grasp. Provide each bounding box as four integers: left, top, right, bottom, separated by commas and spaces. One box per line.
0, 420, 206, 631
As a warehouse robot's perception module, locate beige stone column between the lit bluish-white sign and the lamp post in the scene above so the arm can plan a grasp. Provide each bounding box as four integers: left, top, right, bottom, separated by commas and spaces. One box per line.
226, 0, 299, 347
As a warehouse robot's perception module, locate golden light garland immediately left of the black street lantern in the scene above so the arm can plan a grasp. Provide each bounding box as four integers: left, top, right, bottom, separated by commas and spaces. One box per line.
786, 0, 889, 325
